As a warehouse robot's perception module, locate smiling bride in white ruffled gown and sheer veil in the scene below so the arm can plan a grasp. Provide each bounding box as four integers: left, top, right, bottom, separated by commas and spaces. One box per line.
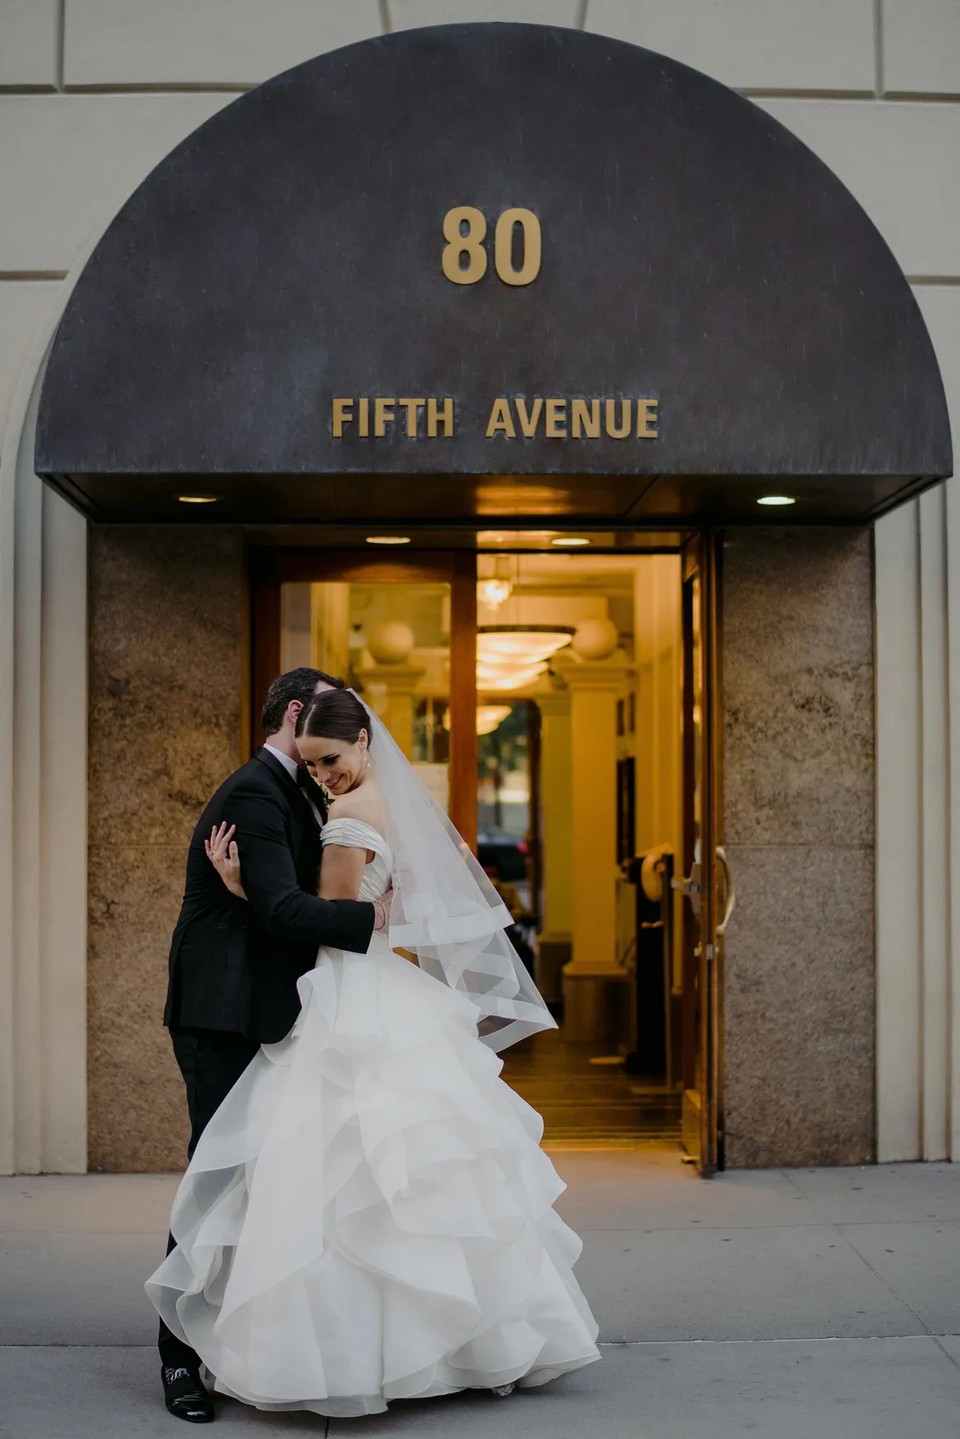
147, 689, 600, 1417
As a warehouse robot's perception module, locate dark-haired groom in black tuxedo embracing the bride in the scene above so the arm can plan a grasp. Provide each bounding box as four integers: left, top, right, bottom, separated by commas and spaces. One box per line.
160, 669, 389, 1423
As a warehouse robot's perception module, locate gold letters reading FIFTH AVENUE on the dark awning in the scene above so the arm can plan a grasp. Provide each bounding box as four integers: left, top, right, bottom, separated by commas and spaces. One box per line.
330, 394, 659, 440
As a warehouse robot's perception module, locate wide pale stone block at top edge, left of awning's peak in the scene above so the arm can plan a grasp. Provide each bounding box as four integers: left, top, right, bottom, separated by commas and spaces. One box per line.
63, 0, 380, 86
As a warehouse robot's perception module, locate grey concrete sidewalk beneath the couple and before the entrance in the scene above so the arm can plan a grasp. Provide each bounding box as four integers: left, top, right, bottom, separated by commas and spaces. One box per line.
0, 1150, 960, 1439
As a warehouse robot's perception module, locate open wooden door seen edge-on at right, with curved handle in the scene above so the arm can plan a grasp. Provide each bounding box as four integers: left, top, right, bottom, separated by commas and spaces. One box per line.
674, 532, 733, 1179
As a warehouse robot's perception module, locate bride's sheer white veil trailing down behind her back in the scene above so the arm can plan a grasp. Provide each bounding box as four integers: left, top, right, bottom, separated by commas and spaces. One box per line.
351, 691, 557, 1050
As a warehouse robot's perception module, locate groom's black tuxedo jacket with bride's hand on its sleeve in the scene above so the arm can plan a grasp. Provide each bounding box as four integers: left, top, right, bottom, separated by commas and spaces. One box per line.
164, 750, 374, 1043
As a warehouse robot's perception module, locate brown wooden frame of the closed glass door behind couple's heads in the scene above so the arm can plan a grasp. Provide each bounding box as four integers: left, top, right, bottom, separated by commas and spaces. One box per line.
246, 545, 476, 849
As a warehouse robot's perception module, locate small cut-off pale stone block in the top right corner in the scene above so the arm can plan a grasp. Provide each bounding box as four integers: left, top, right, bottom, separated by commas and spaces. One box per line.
882, 0, 960, 95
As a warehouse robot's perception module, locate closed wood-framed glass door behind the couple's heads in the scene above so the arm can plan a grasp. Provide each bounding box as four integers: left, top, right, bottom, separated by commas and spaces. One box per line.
250, 550, 478, 845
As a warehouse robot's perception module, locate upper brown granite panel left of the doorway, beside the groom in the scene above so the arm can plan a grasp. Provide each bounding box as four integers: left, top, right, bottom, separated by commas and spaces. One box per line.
89, 527, 243, 845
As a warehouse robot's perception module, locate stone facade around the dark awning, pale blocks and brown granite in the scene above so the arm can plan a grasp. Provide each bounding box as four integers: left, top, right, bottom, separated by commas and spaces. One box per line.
0, 0, 960, 1170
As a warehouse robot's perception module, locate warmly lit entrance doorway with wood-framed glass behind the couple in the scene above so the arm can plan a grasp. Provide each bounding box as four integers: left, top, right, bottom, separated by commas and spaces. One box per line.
250, 531, 721, 1174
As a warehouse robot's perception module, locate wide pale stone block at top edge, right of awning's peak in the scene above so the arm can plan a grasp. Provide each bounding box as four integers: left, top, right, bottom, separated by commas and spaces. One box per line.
586, 0, 874, 92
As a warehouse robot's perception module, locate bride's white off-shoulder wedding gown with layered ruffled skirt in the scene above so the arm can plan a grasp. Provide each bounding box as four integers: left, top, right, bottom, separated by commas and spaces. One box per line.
147, 819, 600, 1417
